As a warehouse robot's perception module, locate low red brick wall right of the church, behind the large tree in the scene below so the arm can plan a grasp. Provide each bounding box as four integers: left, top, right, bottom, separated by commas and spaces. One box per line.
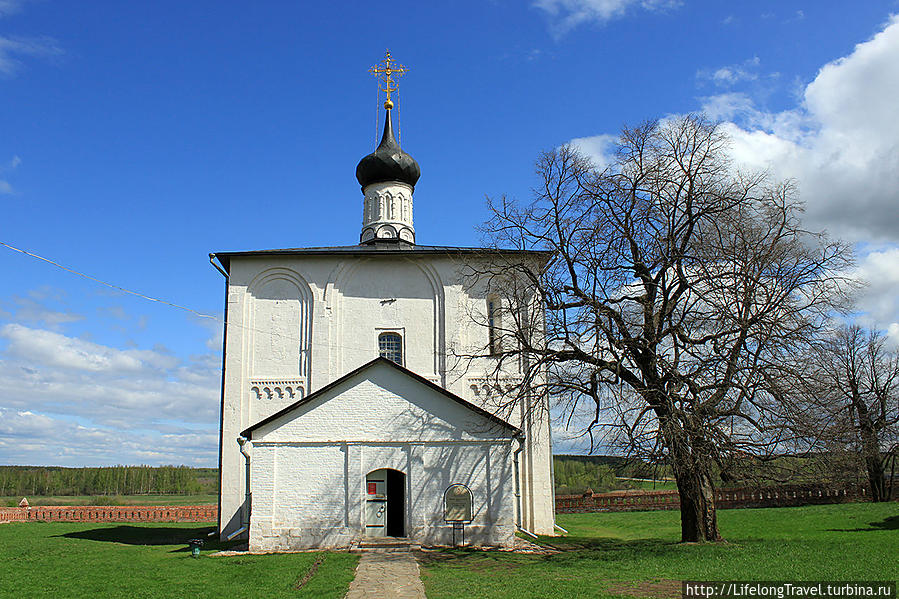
556, 485, 868, 514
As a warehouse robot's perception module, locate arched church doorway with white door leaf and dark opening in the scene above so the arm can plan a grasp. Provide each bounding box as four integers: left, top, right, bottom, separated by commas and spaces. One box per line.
365, 468, 406, 537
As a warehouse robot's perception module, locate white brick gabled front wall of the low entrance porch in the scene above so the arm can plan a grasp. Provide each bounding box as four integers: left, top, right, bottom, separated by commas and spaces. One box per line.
250, 364, 515, 551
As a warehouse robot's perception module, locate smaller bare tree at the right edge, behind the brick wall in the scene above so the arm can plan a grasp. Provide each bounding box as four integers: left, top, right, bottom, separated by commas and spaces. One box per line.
803, 325, 899, 501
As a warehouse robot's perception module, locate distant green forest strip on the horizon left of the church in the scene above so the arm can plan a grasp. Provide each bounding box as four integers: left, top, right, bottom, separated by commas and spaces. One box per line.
0, 466, 218, 497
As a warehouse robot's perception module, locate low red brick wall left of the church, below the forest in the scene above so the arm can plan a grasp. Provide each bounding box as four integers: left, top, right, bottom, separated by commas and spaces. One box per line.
0, 505, 218, 522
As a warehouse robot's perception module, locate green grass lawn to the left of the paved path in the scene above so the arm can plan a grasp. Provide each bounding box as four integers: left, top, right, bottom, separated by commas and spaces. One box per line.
0, 522, 358, 599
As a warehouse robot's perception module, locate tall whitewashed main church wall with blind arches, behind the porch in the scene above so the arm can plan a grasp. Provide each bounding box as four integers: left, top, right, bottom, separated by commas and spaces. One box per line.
221, 253, 553, 534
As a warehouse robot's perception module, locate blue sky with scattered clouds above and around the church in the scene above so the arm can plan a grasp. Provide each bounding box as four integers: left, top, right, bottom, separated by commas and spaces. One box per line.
0, 0, 899, 465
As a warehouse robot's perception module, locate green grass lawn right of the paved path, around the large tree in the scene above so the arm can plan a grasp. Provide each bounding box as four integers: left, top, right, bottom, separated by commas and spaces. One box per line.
422, 503, 899, 599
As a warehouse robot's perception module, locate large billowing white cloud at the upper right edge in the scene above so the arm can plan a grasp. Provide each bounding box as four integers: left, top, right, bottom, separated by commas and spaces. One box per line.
703, 16, 899, 241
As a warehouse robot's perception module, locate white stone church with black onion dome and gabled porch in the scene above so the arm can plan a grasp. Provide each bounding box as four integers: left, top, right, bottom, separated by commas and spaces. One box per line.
211, 90, 554, 551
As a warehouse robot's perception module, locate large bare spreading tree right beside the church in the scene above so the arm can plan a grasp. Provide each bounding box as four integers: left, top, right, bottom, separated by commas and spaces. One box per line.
478, 116, 850, 541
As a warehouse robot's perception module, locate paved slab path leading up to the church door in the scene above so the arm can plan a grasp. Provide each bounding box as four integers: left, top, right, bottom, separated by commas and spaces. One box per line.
346, 551, 425, 599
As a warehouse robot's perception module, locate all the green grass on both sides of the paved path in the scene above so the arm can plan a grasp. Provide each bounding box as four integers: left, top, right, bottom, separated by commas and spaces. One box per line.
0, 503, 899, 599
